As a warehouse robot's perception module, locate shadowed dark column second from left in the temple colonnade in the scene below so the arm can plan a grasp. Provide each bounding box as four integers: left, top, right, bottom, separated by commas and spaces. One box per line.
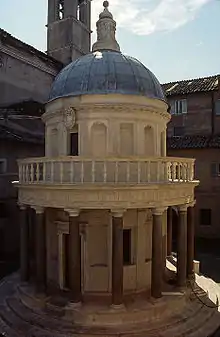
33, 206, 47, 291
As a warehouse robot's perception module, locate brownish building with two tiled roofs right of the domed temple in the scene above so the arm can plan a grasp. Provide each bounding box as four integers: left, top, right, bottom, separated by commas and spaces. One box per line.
163, 76, 220, 238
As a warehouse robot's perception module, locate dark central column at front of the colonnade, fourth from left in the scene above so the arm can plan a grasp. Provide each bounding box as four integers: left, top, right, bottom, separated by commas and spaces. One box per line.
112, 210, 124, 306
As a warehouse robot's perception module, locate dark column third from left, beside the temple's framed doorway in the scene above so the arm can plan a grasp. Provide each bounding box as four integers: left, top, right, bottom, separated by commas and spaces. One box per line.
65, 209, 82, 304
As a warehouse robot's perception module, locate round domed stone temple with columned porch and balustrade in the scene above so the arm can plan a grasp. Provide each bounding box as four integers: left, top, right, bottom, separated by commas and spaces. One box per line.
3, 1, 220, 337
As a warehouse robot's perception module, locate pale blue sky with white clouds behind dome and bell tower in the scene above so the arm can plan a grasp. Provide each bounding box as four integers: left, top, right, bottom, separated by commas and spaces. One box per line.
0, 0, 220, 83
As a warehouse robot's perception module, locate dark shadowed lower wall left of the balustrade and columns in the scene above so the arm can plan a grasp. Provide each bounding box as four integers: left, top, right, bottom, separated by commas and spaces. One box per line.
0, 140, 44, 259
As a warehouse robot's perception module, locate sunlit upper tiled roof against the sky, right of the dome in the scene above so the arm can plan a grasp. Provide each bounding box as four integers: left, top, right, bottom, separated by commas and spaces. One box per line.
162, 75, 220, 96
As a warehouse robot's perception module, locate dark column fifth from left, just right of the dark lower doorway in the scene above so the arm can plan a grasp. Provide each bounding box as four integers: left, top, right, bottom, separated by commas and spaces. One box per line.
151, 208, 166, 298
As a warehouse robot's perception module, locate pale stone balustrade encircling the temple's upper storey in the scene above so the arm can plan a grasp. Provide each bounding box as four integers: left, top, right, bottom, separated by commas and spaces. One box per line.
18, 157, 195, 184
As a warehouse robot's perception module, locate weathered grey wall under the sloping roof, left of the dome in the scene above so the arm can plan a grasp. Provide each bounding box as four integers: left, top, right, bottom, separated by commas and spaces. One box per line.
0, 40, 58, 106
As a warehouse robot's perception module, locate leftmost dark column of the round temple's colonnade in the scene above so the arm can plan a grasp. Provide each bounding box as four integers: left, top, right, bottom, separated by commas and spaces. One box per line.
19, 205, 29, 282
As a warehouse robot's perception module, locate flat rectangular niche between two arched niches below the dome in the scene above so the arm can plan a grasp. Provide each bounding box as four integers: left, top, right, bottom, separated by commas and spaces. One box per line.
120, 123, 134, 156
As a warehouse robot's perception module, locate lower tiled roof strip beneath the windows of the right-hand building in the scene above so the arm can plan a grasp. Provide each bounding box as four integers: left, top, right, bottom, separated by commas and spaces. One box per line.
167, 135, 220, 150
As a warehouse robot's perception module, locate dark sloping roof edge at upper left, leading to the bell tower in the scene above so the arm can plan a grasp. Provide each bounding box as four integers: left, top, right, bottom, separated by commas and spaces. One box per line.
0, 28, 63, 70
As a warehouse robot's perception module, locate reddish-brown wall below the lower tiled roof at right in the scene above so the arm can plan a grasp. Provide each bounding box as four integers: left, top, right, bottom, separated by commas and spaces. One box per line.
168, 149, 220, 238
